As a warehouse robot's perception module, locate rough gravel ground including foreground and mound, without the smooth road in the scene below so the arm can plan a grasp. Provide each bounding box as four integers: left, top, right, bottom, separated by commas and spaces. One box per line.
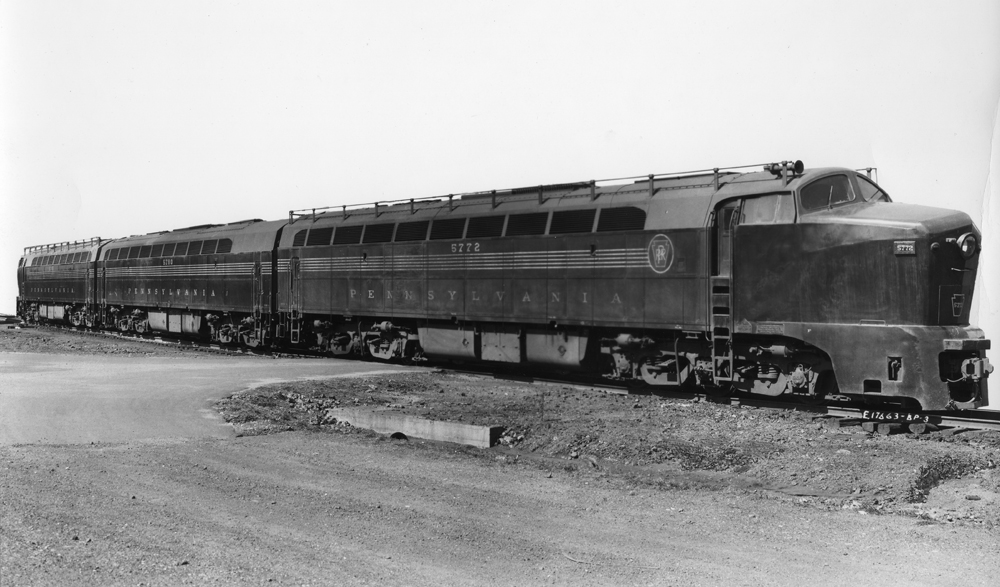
0, 330, 1000, 587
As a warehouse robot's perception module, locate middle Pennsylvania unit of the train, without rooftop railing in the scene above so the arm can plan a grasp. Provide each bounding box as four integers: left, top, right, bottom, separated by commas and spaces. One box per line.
97, 219, 284, 347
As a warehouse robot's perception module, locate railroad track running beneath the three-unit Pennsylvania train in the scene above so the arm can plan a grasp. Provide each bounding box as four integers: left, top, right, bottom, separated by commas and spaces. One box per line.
19, 324, 1000, 434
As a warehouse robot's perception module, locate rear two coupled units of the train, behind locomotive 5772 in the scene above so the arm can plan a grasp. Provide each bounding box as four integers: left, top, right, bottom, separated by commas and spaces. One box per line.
18, 220, 285, 346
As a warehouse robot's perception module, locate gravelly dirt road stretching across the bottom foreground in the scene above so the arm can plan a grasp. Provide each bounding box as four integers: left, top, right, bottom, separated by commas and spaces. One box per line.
7, 432, 1000, 586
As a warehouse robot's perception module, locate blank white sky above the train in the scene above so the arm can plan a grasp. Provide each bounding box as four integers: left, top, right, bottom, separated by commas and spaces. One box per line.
0, 0, 1000, 339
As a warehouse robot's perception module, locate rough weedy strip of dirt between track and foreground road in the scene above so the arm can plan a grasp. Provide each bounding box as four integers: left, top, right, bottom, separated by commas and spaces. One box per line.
219, 372, 1000, 531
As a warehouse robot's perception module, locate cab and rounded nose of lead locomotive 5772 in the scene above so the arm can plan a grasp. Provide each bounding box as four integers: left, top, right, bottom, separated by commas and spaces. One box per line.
732, 169, 992, 410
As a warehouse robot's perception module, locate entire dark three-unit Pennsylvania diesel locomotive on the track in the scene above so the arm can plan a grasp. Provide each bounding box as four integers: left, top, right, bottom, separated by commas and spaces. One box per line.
17, 161, 992, 410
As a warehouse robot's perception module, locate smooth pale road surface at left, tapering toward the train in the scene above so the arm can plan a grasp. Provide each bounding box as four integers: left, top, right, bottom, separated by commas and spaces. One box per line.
0, 342, 418, 445
